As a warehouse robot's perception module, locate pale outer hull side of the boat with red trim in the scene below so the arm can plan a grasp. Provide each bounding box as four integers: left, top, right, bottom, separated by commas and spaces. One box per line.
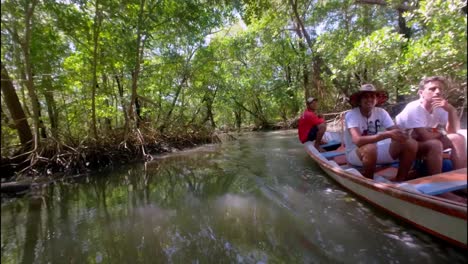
305, 142, 467, 248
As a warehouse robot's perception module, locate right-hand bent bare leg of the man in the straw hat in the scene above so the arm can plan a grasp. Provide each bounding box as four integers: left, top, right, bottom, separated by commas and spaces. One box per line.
389, 139, 418, 181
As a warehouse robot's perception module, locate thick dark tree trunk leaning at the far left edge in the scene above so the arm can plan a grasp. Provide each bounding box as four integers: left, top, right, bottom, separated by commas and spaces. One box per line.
1, 62, 33, 149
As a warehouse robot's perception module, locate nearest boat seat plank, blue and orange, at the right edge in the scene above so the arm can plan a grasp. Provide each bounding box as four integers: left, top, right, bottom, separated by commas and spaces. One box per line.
398, 168, 467, 195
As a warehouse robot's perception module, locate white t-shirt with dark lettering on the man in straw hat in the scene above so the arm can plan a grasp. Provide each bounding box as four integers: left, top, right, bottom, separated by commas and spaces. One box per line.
344, 107, 395, 153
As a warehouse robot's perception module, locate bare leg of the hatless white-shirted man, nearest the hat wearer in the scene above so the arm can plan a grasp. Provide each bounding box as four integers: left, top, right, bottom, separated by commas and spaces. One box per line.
418, 139, 443, 175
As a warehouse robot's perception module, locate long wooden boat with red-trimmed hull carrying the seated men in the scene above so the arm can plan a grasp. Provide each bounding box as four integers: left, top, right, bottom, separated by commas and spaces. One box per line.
305, 132, 467, 248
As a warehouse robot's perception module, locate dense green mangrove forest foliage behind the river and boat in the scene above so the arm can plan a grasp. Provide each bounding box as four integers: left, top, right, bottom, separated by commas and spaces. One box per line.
1, 0, 467, 160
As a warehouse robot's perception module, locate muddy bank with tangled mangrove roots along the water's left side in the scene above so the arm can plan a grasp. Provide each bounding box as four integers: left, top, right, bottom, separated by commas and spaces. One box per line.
0, 130, 235, 197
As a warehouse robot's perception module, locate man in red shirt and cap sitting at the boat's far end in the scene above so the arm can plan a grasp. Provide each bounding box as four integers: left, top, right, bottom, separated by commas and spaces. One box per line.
298, 97, 327, 152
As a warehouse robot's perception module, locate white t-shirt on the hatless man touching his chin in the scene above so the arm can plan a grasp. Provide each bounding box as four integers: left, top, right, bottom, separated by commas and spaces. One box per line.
395, 100, 448, 129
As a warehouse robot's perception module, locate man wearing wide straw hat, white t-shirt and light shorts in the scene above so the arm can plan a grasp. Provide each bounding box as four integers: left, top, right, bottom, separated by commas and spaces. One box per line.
344, 84, 418, 181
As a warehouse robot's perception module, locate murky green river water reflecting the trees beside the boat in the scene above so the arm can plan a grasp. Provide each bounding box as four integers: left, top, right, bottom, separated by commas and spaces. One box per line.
1, 131, 468, 263
